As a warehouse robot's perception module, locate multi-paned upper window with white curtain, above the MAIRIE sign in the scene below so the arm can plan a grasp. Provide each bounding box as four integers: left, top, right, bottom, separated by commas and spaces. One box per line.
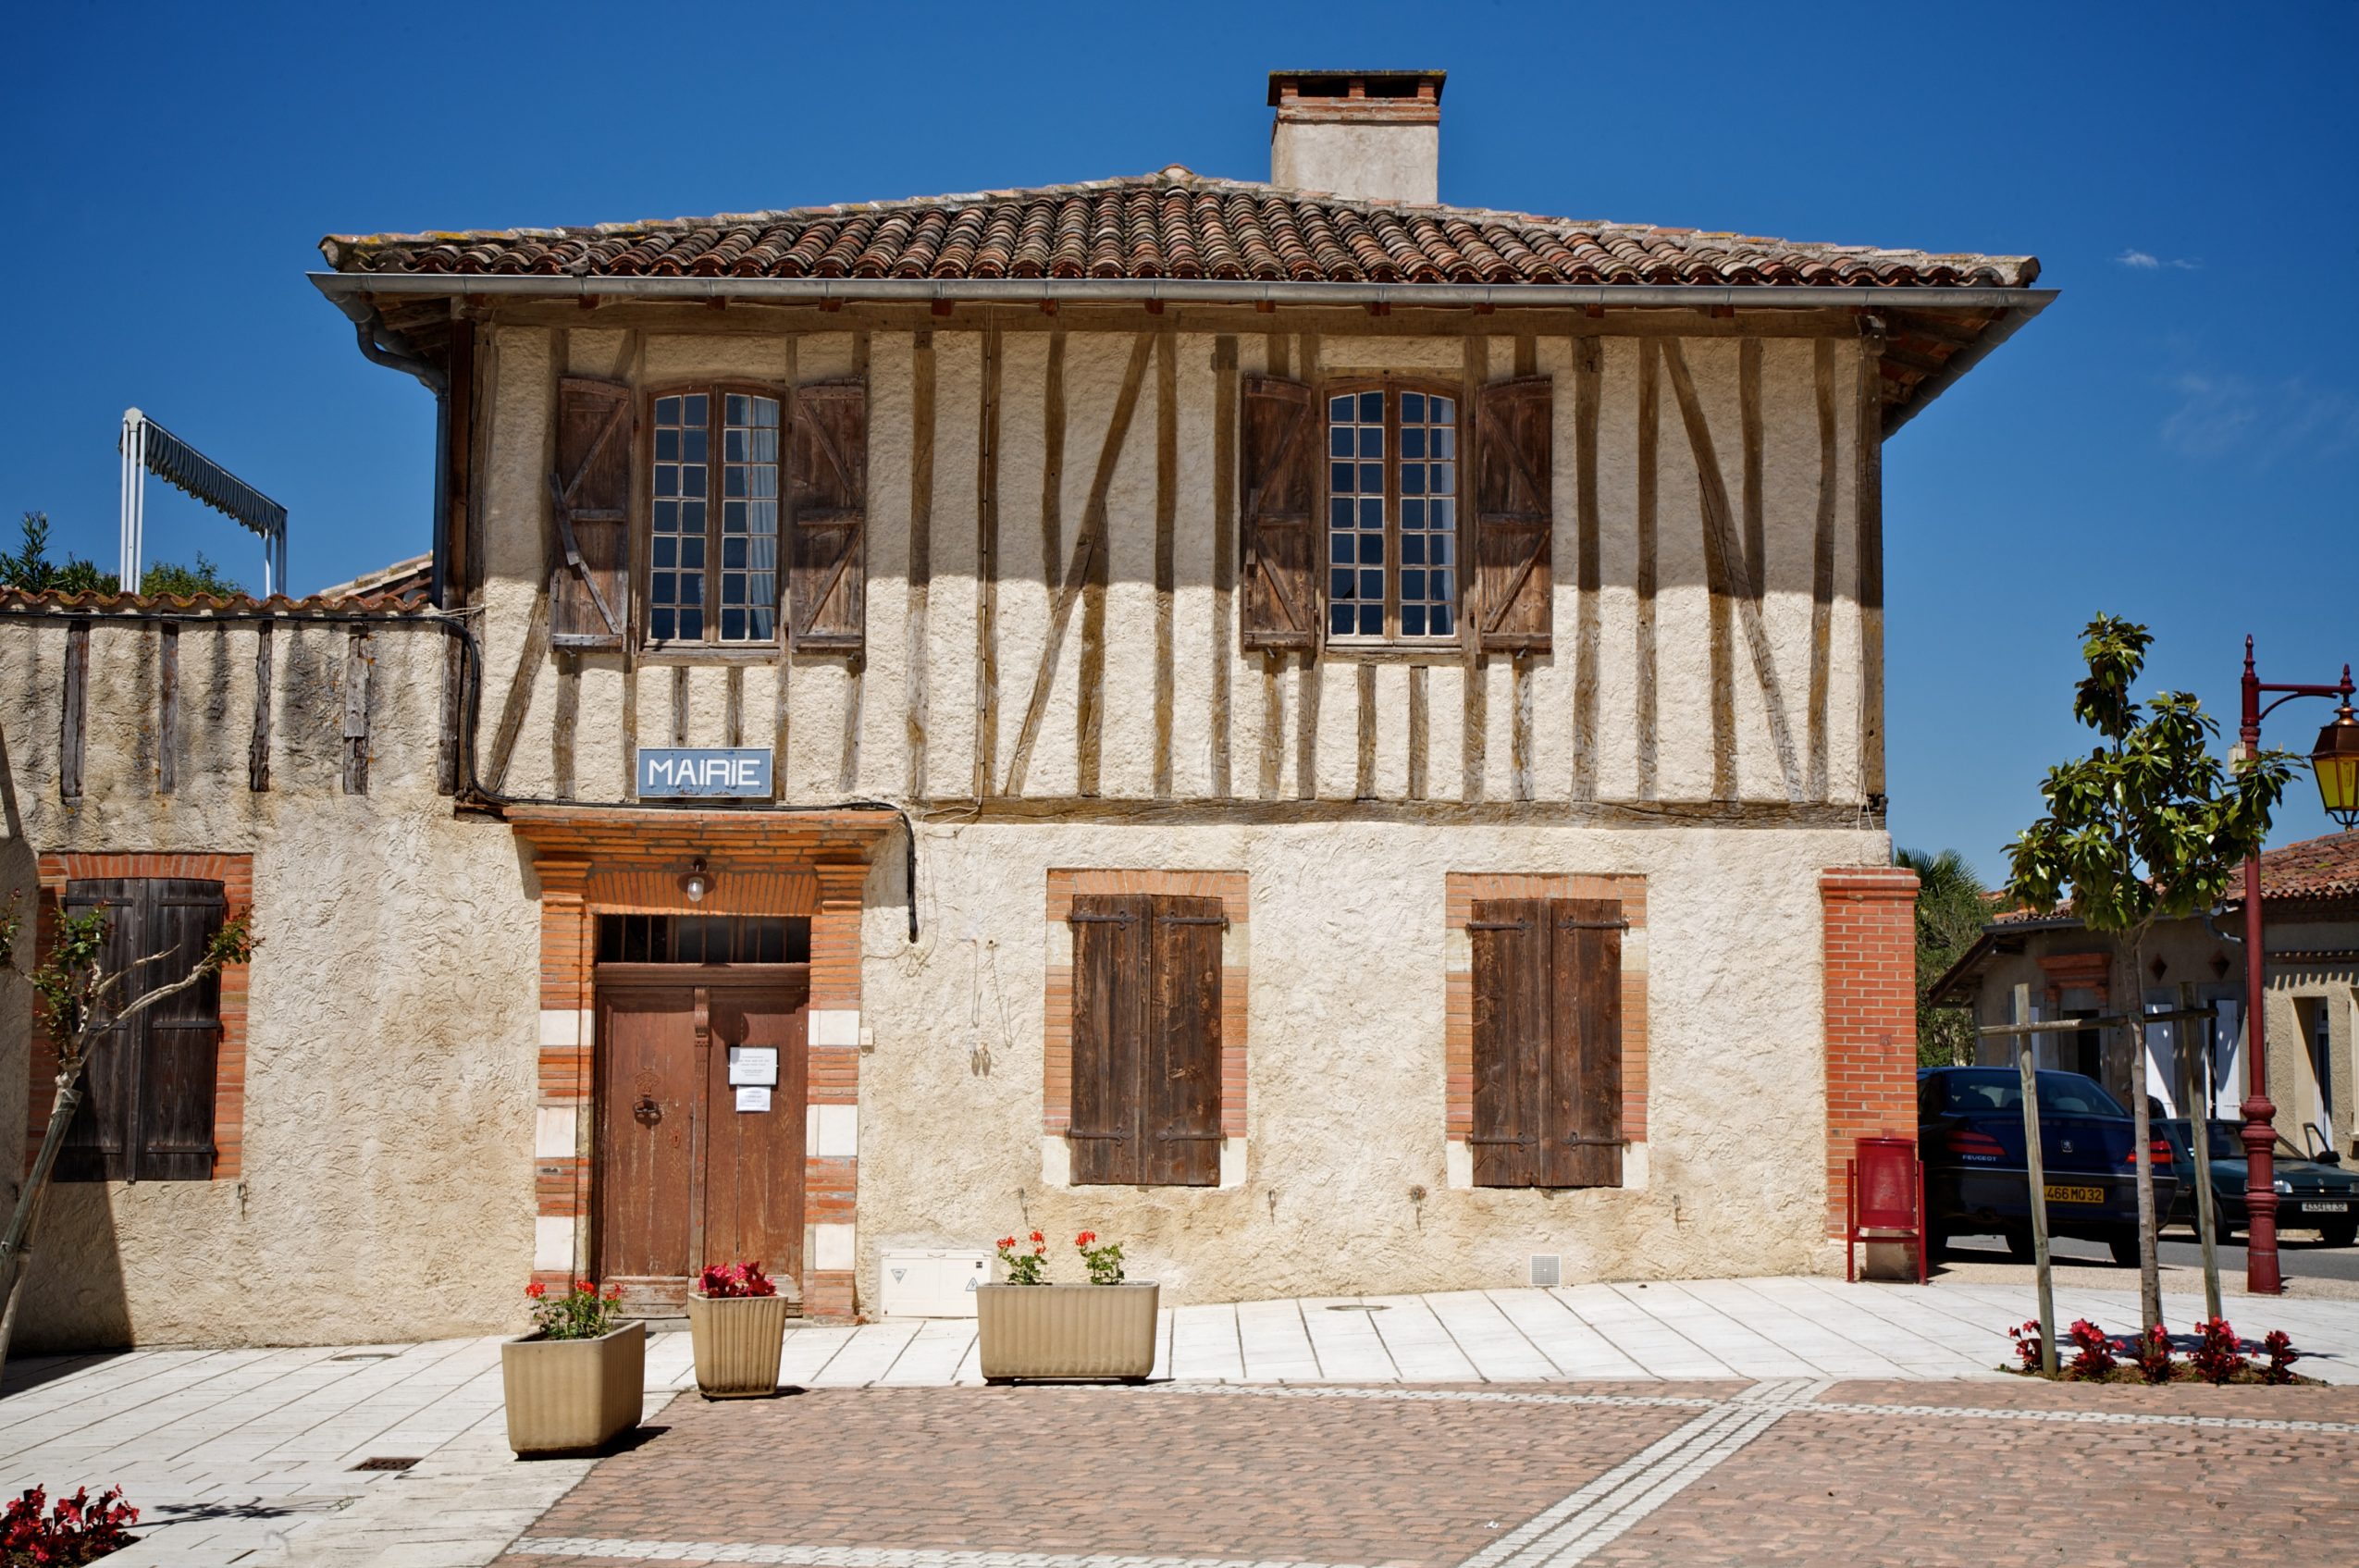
647, 387, 779, 644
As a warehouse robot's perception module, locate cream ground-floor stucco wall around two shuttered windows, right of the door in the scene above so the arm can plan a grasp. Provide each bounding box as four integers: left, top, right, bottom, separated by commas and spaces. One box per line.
858, 810, 1883, 1302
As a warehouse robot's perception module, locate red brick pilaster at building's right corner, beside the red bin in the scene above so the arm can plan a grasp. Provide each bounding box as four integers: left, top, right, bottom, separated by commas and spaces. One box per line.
1819, 865, 1918, 1236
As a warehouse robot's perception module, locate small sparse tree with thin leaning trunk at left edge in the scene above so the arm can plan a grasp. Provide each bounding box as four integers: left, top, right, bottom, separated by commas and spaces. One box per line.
0, 898, 254, 1361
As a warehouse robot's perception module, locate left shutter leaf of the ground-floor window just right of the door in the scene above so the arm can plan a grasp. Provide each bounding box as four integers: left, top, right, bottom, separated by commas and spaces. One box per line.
1067, 894, 1154, 1186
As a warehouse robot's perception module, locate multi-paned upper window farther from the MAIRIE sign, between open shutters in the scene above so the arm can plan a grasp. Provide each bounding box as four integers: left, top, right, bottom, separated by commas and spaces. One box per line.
1328, 384, 1458, 641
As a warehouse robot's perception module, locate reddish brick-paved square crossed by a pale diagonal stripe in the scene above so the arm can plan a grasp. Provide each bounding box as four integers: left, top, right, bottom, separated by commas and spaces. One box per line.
500, 1379, 2359, 1568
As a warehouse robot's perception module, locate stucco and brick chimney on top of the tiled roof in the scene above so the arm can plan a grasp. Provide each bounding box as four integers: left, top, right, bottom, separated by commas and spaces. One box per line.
1269, 70, 1446, 203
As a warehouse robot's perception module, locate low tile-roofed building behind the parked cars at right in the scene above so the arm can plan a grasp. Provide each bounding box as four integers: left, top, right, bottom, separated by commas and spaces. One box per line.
1930, 833, 2359, 1157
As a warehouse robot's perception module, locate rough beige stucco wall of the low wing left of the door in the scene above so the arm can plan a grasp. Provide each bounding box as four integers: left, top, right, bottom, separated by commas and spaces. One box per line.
0, 624, 537, 1349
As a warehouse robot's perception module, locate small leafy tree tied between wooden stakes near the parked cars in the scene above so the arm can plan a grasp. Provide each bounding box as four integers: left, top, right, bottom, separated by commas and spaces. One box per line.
2006, 615, 2293, 1330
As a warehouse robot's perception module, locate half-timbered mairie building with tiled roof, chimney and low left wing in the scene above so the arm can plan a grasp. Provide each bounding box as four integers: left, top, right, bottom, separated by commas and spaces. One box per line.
0, 73, 2053, 1344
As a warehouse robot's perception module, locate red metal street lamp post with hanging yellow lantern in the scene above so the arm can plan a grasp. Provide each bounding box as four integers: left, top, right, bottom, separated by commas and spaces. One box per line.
2205, 636, 2359, 1294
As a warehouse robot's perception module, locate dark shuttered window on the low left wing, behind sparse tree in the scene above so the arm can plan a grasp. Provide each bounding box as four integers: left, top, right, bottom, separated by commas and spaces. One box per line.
56, 877, 227, 1181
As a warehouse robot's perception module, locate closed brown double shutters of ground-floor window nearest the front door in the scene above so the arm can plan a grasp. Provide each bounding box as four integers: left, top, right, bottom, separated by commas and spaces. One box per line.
1067, 894, 1229, 1186
